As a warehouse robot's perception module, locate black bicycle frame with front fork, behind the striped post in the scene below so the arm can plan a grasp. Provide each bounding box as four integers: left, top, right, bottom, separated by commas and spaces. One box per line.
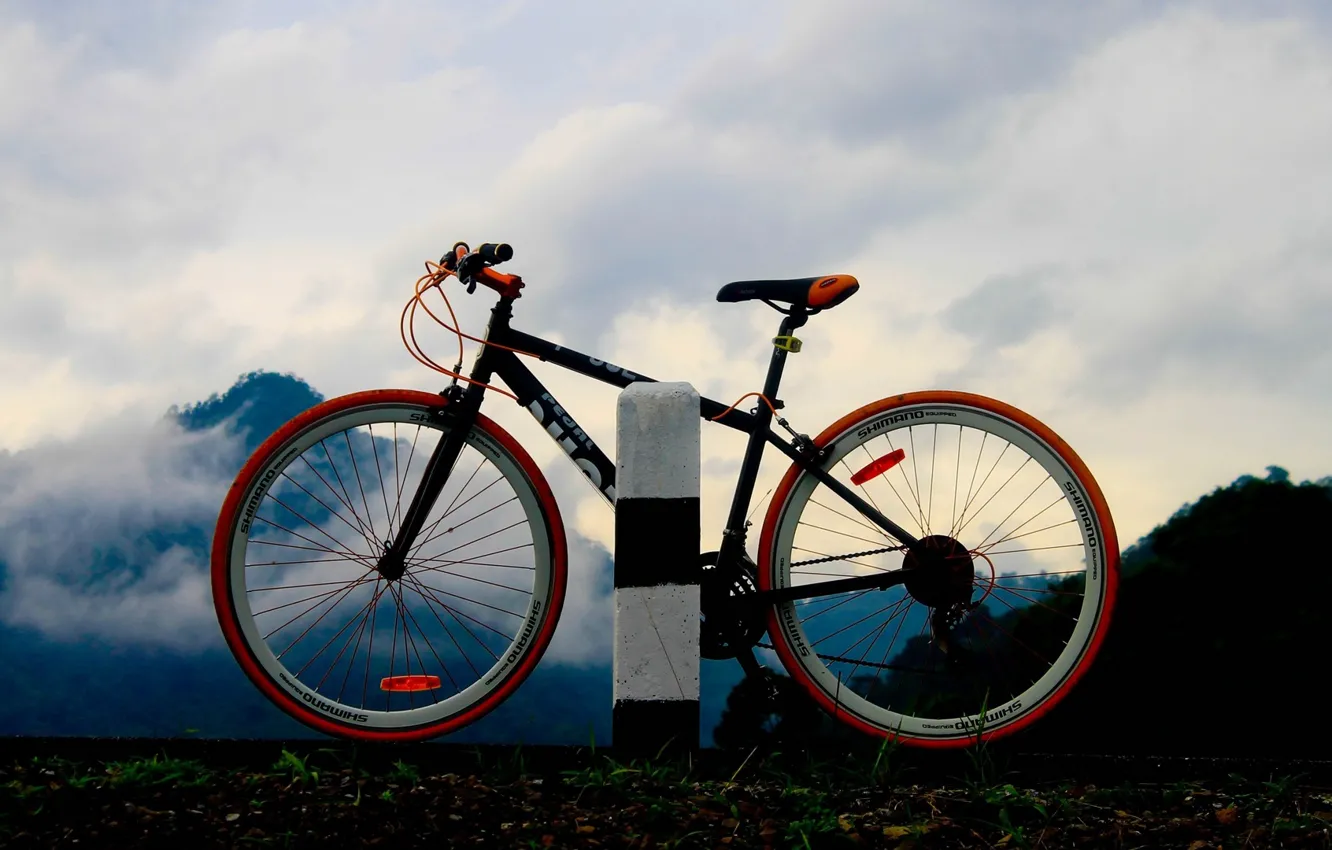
381, 297, 918, 604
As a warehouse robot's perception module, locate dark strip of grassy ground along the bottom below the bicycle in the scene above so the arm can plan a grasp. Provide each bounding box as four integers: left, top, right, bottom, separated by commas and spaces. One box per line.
0, 739, 1332, 849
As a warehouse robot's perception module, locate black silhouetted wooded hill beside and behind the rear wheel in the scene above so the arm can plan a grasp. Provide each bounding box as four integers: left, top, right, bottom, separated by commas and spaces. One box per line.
715, 466, 1332, 758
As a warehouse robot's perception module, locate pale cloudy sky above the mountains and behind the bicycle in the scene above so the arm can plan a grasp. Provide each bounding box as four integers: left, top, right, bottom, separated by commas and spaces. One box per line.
0, 0, 1332, 658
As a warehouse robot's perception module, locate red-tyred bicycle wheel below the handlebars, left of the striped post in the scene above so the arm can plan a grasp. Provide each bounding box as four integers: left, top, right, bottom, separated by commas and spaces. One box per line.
212, 390, 567, 741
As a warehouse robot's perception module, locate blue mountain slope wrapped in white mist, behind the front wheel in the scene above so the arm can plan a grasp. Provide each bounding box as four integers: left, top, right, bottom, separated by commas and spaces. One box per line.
0, 370, 739, 743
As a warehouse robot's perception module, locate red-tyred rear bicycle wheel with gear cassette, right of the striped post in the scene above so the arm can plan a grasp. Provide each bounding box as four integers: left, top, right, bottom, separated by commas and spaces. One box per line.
758, 392, 1119, 747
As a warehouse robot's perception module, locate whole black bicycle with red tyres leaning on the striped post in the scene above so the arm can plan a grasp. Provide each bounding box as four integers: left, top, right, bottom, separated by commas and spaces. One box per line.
212, 242, 1119, 747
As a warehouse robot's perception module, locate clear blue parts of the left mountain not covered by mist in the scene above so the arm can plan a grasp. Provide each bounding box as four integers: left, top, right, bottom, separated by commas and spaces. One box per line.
0, 370, 739, 743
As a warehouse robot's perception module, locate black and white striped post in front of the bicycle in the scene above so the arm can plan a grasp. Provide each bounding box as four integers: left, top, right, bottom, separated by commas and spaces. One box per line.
611, 382, 701, 755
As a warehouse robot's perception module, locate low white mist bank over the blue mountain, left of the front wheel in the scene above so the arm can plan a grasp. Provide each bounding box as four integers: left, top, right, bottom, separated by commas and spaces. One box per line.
0, 417, 238, 649
